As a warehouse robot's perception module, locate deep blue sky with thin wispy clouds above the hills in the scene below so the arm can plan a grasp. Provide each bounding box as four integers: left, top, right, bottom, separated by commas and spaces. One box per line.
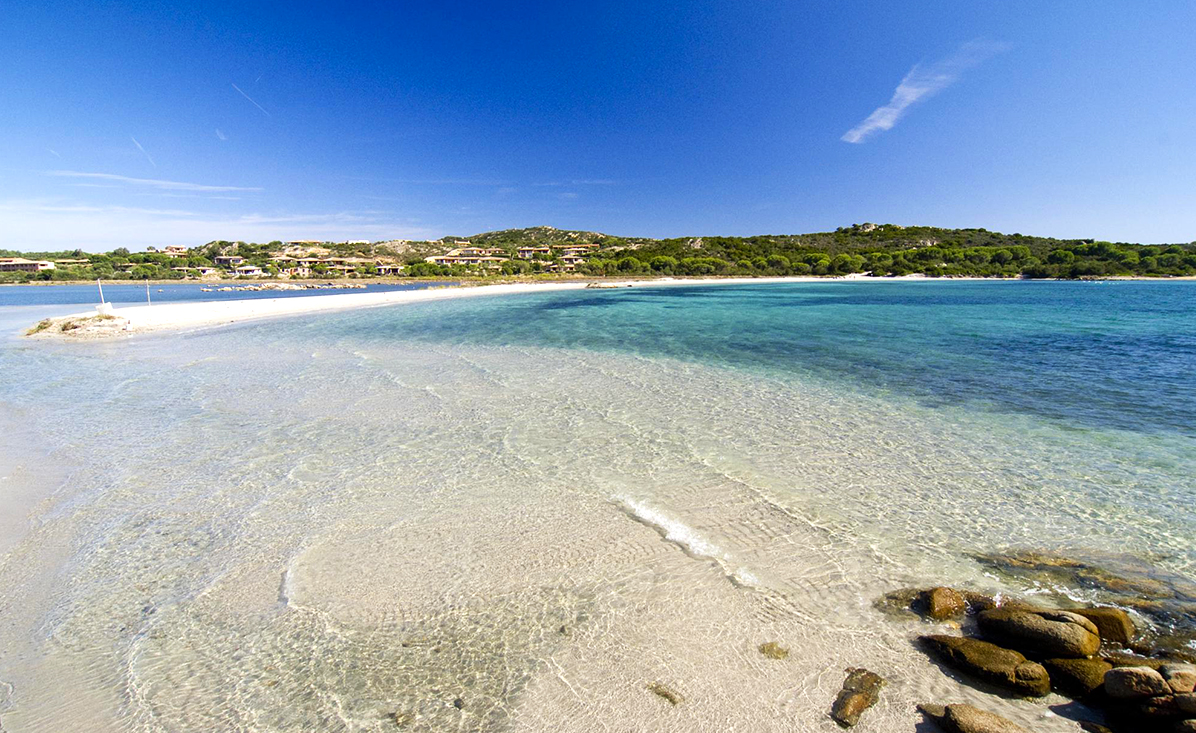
0, 0, 1196, 250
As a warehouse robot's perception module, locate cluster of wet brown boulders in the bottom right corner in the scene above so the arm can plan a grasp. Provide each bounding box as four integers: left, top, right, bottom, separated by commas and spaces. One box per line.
875, 552, 1196, 733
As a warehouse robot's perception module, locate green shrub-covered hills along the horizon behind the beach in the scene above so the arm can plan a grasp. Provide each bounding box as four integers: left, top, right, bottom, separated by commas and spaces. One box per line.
0, 224, 1196, 281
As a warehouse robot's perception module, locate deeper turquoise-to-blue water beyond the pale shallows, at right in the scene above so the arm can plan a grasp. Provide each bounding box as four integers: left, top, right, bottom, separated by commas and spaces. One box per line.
315, 282, 1196, 435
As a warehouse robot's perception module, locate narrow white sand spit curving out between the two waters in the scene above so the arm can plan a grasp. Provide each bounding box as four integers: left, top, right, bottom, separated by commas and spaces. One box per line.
25, 277, 828, 338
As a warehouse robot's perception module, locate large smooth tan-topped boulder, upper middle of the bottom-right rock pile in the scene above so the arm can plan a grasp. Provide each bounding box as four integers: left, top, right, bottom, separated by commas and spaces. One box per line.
976, 609, 1100, 658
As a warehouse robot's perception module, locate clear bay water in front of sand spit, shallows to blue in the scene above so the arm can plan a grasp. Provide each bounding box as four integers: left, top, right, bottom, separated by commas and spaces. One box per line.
0, 281, 1196, 732
